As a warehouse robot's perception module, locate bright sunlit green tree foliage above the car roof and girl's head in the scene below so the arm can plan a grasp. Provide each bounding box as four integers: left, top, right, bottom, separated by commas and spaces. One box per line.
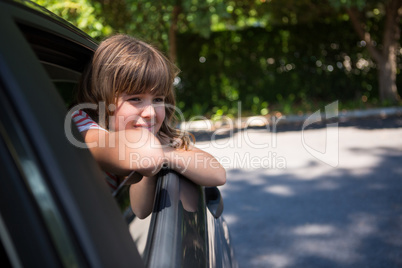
34, 0, 220, 62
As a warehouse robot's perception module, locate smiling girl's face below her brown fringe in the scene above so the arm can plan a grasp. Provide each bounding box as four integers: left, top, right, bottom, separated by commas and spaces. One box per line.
110, 93, 165, 135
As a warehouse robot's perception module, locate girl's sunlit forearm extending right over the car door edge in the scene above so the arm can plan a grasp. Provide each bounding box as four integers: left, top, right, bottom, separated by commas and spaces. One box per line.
164, 147, 226, 186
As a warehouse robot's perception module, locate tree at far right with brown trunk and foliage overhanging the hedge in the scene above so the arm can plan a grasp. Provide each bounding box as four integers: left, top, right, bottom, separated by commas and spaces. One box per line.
221, 0, 402, 103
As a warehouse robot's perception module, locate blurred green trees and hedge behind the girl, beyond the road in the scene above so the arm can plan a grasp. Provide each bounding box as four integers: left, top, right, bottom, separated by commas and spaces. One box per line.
35, 0, 402, 120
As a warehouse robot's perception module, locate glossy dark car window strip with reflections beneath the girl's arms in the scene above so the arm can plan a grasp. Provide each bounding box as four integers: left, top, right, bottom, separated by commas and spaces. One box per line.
145, 170, 209, 267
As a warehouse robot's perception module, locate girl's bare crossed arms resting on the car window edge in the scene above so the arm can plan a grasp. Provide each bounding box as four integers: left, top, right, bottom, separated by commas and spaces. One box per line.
84, 129, 226, 218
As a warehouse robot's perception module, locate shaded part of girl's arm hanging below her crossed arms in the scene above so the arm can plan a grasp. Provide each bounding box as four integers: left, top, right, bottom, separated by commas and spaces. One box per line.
130, 176, 157, 219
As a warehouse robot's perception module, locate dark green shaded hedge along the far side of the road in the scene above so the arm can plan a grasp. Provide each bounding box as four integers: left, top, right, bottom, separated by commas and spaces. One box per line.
177, 20, 402, 118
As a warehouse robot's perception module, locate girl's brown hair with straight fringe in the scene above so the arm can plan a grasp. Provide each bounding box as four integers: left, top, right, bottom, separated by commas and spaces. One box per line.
77, 34, 190, 149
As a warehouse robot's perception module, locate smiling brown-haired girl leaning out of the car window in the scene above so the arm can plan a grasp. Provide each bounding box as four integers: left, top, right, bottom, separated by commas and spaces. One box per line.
73, 35, 226, 218
